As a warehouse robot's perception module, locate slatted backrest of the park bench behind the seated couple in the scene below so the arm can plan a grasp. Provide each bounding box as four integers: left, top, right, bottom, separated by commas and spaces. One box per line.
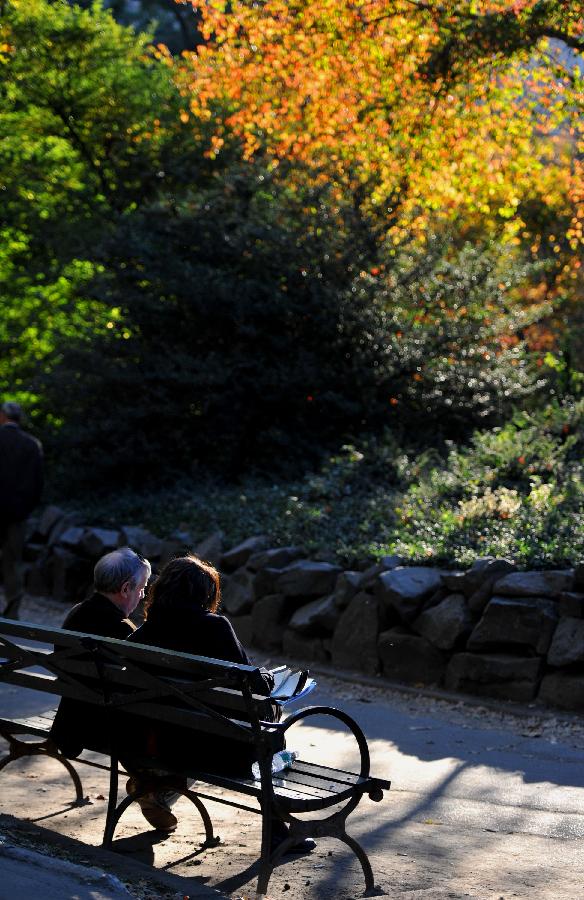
0, 618, 280, 749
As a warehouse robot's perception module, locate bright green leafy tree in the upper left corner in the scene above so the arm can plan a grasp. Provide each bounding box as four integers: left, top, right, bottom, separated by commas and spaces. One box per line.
0, 0, 209, 424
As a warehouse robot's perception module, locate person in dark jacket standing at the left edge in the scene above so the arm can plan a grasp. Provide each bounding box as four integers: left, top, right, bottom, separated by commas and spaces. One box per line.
0, 401, 43, 619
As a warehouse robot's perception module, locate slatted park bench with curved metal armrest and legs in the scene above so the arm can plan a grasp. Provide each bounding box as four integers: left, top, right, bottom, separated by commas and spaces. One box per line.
0, 618, 390, 896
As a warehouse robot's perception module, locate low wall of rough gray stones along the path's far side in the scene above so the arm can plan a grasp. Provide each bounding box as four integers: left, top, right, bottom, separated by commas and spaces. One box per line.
17, 507, 584, 710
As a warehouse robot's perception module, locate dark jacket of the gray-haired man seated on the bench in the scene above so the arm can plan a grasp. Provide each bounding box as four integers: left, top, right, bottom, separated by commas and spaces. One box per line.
51, 593, 135, 758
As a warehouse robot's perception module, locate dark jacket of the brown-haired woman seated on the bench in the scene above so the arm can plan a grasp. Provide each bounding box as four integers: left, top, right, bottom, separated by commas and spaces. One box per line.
129, 607, 279, 775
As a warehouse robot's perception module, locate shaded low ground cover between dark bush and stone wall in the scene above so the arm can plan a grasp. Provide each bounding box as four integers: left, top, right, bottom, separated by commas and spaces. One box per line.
74, 433, 400, 565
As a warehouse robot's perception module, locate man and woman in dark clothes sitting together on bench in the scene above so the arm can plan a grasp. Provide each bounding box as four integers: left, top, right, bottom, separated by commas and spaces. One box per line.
51, 547, 315, 852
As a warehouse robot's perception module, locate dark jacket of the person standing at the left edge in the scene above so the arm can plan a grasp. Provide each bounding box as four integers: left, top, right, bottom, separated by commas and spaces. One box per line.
0, 423, 43, 526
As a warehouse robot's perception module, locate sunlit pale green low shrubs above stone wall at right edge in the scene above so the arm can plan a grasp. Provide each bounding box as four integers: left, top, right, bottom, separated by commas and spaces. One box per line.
391, 399, 584, 566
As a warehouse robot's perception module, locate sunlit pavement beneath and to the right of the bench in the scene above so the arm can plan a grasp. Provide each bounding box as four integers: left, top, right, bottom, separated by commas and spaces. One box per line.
2, 684, 584, 900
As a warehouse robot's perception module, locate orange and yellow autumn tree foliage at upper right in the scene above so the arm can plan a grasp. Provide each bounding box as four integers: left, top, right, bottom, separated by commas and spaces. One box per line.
174, 0, 584, 249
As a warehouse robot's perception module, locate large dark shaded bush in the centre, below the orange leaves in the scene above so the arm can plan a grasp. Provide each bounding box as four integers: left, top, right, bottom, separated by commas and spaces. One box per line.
34, 158, 544, 481
